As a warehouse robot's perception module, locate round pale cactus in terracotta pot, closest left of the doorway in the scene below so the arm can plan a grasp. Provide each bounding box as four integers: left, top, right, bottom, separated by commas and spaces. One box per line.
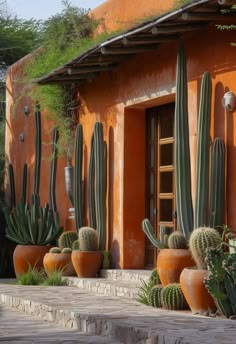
71, 227, 103, 277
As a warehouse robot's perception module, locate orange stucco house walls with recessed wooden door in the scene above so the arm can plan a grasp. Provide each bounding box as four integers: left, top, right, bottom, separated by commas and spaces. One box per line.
6, 0, 236, 269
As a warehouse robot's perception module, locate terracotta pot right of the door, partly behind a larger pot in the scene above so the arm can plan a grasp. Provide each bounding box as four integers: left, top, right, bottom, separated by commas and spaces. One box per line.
157, 248, 195, 286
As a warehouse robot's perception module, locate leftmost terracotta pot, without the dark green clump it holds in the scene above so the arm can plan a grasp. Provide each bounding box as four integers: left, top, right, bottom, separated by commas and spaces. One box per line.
13, 245, 52, 276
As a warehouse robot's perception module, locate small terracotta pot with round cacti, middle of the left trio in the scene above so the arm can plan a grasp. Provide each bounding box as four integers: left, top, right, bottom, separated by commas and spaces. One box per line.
43, 231, 78, 276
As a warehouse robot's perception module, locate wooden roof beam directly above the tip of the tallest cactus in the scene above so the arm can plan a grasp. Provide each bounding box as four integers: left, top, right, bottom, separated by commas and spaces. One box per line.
152, 23, 207, 35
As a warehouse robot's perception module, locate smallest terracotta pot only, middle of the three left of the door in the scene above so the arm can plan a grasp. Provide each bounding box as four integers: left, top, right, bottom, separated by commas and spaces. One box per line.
43, 252, 76, 276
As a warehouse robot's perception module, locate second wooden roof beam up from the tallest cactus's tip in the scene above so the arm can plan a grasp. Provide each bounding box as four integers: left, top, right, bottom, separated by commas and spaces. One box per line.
181, 12, 236, 21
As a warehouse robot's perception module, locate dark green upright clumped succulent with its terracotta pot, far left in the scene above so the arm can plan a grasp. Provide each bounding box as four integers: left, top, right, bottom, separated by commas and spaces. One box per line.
3, 195, 62, 276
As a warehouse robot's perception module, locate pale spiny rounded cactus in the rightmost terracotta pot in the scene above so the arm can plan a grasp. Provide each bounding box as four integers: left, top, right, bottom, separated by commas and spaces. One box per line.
189, 227, 221, 270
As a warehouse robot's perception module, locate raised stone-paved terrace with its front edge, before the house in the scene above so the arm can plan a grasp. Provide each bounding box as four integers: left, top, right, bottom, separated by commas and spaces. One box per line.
0, 285, 236, 344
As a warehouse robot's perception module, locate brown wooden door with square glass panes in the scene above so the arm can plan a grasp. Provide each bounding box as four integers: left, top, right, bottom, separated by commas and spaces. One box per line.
145, 103, 176, 268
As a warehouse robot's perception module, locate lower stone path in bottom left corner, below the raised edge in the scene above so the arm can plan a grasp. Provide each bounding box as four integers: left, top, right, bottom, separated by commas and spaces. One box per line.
0, 306, 121, 344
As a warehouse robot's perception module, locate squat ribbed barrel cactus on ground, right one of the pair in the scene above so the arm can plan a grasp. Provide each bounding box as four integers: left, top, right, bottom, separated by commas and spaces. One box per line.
161, 283, 189, 310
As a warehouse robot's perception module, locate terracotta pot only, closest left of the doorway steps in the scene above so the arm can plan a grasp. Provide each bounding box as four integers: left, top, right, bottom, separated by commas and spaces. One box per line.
71, 251, 103, 277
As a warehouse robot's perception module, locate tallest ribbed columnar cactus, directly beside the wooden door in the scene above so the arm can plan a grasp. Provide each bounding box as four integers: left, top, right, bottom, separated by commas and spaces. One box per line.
175, 43, 193, 238
